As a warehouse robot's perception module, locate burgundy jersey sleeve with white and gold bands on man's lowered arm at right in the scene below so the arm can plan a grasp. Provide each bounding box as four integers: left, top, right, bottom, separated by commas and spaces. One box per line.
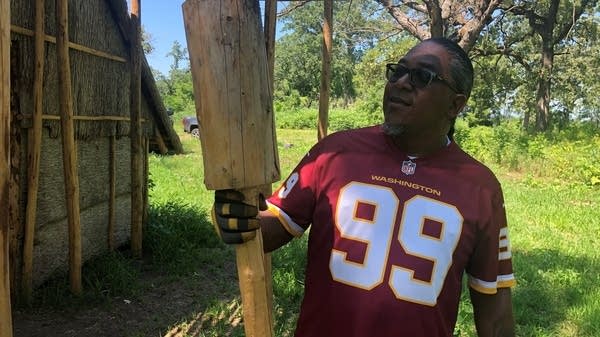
466, 185, 516, 294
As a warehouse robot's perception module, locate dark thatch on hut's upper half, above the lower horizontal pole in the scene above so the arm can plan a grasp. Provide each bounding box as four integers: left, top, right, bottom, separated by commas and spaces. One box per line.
11, 0, 183, 153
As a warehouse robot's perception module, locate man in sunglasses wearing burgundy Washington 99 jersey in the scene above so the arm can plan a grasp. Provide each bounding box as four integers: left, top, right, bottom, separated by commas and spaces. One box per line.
213, 38, 515, 337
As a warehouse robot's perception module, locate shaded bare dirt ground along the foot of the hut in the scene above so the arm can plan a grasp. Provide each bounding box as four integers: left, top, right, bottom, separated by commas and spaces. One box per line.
13, 258, 238, 337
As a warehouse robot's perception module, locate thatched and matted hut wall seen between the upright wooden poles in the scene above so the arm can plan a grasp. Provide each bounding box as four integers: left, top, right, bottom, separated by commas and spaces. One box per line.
11, 0, 154, 286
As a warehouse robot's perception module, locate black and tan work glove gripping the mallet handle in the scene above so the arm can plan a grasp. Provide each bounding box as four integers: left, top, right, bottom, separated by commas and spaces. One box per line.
212, 190, 267, 244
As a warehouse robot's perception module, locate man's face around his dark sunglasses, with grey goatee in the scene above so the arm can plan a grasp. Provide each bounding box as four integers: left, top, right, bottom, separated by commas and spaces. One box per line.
383, 42, 458, 136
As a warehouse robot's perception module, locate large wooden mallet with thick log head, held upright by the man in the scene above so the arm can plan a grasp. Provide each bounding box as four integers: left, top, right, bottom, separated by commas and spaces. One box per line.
183, 0, 280, 337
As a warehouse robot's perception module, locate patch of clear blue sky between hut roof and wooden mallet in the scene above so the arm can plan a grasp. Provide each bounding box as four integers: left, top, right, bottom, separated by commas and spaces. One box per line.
141, 0, 279, 75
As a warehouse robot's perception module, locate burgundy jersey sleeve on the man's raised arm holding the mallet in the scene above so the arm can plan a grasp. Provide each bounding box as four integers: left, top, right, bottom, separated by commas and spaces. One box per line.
267, 144, 322, 237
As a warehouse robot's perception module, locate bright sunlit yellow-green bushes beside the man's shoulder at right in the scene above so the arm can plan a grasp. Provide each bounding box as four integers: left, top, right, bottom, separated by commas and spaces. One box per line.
455, 120, 600, 186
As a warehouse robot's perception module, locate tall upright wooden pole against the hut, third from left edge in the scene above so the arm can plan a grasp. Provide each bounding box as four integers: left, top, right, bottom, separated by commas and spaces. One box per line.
56, 0, 81, 295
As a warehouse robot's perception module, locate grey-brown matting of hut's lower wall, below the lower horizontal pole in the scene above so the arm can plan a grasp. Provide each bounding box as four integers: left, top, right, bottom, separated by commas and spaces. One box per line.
33, 132, 131, 285
